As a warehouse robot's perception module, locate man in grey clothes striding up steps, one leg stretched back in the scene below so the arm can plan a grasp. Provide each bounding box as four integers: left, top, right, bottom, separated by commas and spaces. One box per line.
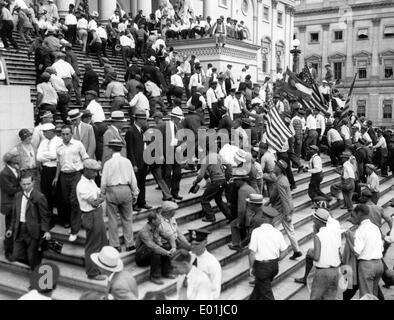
270, 160, 302, 260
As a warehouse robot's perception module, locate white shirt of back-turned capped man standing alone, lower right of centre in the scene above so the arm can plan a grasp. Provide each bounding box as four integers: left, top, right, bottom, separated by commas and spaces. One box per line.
249, 223, 287, 261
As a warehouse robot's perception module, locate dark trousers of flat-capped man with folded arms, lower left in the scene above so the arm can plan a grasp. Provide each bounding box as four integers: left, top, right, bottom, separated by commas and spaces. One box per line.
81, 208, 108, 277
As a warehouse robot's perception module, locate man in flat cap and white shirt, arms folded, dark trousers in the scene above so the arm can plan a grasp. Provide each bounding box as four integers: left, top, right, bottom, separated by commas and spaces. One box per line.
76, 159, 108, 281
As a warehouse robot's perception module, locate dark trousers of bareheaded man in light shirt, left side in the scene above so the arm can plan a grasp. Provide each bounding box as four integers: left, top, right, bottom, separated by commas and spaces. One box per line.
60, 171, 81, 235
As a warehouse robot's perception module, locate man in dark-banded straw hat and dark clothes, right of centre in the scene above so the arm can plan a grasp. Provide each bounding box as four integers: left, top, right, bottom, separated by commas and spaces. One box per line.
229, 168, 256, 251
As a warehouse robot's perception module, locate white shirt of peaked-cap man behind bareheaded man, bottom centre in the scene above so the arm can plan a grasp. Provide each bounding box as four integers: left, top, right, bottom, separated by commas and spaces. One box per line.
197, 250, 222, 299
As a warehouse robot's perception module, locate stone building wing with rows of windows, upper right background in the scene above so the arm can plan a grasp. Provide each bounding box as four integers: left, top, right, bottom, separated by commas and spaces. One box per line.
295, 0, 394, 126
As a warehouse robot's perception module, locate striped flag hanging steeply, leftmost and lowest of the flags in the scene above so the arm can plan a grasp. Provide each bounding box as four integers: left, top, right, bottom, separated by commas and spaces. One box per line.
264, 86, 292, 151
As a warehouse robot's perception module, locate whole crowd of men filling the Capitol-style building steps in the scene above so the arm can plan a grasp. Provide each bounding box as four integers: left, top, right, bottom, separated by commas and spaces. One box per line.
0, 0, 394, 300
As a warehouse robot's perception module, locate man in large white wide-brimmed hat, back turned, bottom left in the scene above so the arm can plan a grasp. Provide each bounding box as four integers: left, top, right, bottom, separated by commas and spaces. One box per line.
90, 247, 138, 300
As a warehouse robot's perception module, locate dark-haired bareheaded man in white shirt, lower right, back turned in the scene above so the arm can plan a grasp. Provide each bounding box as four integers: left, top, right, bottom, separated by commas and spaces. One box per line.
345, 205, 383, 297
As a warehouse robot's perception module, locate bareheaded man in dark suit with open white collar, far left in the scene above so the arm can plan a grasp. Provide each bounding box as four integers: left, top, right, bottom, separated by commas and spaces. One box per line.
6, 174, 51, 270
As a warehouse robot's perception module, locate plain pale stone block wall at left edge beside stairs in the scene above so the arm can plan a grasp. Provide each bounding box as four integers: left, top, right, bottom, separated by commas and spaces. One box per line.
0, 86, 34, 250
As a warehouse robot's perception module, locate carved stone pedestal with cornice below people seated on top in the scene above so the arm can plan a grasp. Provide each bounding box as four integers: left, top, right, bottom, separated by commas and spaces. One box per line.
167, 38, 264, 82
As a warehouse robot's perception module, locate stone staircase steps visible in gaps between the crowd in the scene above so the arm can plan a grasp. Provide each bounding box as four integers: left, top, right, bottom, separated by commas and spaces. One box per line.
0, 31, 393, 300
